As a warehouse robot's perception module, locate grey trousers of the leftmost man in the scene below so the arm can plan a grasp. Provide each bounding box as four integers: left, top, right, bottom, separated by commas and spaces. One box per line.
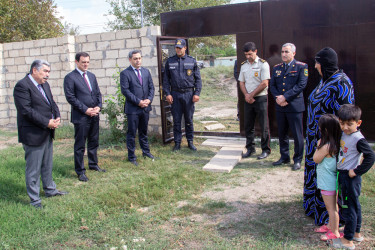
22, 136, 57, 206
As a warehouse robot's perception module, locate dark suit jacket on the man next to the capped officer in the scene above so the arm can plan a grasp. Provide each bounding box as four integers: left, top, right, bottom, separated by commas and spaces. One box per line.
120, 66, 155, 114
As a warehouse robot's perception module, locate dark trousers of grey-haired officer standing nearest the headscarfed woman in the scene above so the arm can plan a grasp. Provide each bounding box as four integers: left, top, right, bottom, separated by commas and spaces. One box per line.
276, 111, 304, 163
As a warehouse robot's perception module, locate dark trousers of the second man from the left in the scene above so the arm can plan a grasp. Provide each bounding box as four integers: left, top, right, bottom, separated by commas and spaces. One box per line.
74, 115, 99, 175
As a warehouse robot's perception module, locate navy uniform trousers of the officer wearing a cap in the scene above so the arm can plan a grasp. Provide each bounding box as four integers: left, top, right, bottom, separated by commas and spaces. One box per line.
171, 89, 195, 144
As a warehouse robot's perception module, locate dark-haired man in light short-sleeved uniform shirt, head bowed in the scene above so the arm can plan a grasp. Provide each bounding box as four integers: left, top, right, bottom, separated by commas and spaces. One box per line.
238, 42, 271, 160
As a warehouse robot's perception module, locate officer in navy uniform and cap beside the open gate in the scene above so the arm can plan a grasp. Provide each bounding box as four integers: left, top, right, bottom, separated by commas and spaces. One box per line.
163, 39, 202, 151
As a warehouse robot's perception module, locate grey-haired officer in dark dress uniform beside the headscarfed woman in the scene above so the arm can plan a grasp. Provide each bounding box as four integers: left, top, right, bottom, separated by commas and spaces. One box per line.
270, 43, 308, 170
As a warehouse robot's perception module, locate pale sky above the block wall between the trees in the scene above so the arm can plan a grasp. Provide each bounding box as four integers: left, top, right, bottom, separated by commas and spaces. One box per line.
54, 0, 251, 35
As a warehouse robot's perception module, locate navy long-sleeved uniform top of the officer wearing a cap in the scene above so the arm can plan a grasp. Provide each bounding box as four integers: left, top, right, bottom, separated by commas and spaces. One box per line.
163, 54, 202, 96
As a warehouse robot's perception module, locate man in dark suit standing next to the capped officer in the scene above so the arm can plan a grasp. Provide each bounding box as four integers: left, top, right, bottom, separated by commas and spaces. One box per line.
120, 50, 154, 166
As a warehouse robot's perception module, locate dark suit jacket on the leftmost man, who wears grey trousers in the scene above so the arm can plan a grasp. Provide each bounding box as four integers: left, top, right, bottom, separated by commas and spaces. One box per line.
13, 75, 60, 146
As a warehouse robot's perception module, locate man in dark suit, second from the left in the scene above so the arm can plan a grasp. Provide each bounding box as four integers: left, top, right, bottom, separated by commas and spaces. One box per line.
64, 52, 105, 181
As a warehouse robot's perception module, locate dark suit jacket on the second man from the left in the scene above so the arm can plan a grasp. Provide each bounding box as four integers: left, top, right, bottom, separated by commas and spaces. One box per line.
64, 69, 102, 123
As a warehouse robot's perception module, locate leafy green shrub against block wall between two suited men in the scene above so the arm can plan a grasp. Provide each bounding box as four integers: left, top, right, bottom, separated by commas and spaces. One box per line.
102, 68, 128, 143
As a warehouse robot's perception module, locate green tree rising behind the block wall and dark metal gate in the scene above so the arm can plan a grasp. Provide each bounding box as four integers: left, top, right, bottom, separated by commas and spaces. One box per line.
107, 0, 230, 30
